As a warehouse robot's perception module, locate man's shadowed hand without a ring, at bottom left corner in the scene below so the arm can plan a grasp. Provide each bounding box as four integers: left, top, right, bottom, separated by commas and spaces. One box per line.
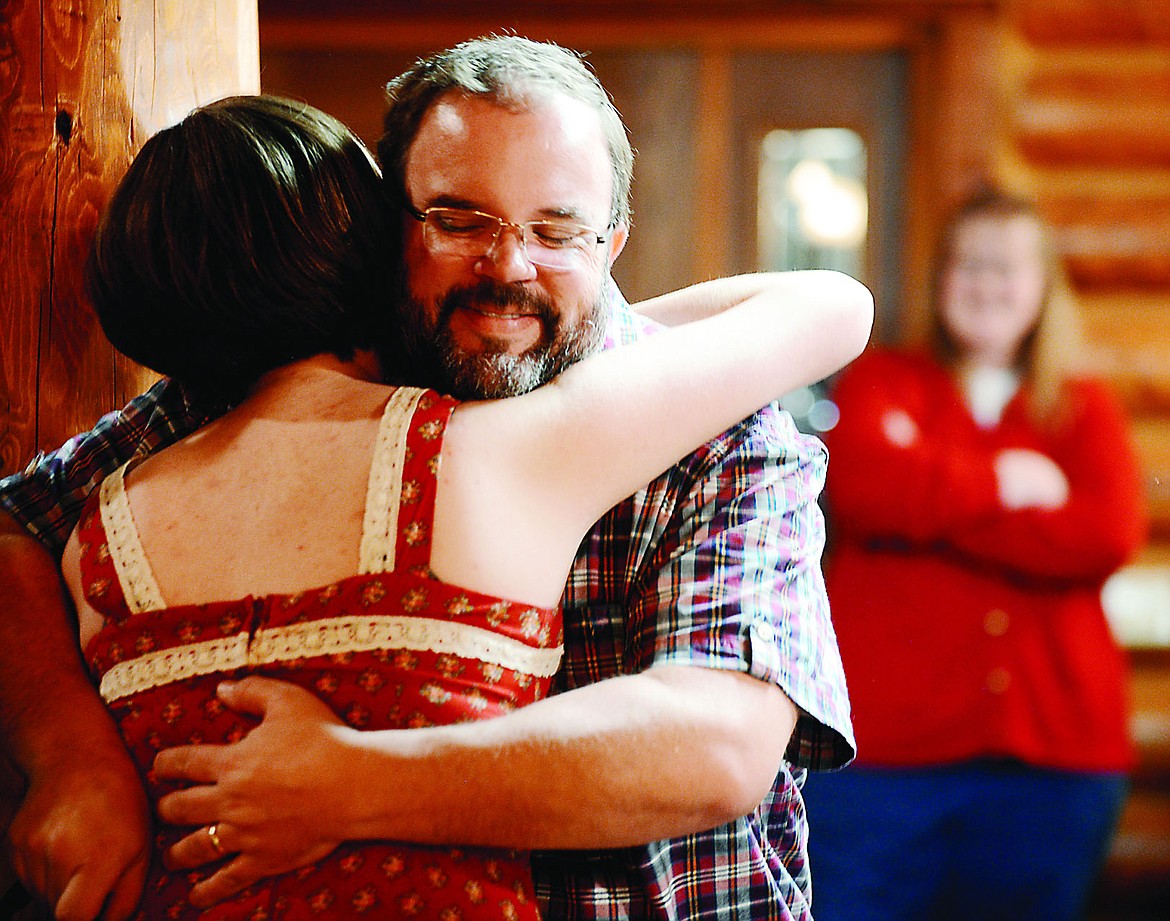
8, 752, 151, 921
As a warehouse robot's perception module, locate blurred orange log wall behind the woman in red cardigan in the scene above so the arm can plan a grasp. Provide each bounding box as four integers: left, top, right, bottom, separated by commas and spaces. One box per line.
998, 0, 1170, 921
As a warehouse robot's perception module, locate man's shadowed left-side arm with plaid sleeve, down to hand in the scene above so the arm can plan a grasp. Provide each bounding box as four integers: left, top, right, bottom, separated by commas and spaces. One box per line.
0, 380, 204, 921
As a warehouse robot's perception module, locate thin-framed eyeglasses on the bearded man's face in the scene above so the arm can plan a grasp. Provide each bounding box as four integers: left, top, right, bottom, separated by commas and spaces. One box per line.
405, 204, 606, 270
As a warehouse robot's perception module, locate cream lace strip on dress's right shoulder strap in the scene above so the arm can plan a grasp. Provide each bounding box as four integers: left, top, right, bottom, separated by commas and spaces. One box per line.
358, 387, 425, 575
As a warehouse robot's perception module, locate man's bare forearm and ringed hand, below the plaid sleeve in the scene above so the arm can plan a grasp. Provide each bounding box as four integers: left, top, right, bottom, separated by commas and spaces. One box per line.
156, 666, 797, 905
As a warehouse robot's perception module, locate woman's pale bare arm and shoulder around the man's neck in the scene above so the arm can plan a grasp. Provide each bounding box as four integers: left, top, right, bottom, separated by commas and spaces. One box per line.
432, 272, 873, 604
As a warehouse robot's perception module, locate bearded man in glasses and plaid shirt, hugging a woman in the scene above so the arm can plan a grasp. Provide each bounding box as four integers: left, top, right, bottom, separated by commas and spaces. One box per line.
0, 37, 853, 919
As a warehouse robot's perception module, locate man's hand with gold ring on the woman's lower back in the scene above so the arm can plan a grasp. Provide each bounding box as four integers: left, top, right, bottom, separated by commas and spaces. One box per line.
154, 678, 355, 908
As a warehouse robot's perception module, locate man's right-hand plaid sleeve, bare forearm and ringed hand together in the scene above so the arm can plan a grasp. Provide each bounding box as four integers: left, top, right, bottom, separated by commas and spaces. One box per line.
156, 407, 852, 905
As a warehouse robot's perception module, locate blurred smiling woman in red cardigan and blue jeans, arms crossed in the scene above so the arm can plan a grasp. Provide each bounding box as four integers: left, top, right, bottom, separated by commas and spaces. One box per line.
805, 190, 1145, 921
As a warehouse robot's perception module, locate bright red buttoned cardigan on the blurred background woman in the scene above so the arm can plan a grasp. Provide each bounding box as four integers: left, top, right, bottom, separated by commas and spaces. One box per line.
826, 351, 1147, 770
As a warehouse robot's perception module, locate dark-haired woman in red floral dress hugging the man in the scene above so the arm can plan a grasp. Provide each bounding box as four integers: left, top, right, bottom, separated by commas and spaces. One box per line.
62, 97, 872, 921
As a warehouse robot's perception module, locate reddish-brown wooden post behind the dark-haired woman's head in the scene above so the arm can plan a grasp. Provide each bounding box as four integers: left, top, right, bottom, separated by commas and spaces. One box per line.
0, 0, 260, 475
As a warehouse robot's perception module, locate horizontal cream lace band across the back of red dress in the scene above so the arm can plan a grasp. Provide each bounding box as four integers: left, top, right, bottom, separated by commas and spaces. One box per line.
101, 616, 564, 703
